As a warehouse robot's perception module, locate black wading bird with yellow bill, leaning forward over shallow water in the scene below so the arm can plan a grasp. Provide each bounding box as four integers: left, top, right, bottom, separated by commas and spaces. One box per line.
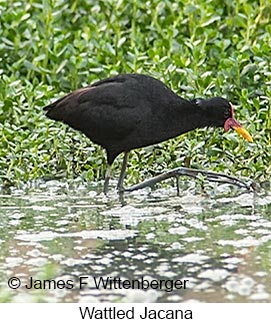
44, 74, 252, 193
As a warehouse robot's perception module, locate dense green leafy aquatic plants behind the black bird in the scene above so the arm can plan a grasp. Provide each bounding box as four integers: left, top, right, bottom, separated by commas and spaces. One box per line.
0, 0, 271, 186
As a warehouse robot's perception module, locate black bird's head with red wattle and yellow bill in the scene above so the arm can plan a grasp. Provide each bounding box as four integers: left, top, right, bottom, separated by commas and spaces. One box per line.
194, 97, 253, 142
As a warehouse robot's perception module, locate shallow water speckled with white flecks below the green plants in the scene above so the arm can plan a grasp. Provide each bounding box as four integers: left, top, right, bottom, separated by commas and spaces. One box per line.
0, 181, 271, 302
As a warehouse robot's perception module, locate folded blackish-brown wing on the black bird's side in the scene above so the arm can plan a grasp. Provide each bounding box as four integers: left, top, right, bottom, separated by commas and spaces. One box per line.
44, 75, 148, 147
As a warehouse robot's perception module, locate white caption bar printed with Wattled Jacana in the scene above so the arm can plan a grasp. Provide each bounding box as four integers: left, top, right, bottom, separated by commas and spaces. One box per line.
0, 303, 271, 323
